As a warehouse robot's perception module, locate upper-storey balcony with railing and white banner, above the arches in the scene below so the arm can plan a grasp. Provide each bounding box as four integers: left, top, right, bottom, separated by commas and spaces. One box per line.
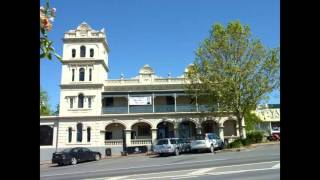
102, 92, 210, 114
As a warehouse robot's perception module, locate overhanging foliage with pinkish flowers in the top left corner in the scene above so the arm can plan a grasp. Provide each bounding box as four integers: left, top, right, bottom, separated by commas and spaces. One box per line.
40, 1, 62, 60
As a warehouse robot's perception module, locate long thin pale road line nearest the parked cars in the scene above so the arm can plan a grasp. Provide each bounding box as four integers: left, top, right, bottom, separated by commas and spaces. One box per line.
40, 159, 227, 177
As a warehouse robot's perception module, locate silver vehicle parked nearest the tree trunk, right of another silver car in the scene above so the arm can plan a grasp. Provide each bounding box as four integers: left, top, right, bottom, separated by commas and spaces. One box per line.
191, 133, 224, 153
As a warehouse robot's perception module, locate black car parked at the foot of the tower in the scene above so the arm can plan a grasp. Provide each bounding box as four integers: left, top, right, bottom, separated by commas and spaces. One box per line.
52, 147, 101, 166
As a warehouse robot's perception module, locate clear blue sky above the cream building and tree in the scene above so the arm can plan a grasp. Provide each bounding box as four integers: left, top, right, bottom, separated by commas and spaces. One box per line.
40, 0, 280, 109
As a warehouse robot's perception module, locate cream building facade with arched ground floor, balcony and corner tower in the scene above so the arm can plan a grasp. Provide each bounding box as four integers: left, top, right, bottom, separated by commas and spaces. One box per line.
40, 23, 245, 159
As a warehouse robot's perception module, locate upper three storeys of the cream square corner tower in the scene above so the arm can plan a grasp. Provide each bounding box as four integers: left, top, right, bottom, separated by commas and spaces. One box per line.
60, 22, 109, 116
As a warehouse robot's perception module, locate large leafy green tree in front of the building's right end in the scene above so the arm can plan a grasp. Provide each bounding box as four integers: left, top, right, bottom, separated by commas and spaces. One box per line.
186, 21, 280, 138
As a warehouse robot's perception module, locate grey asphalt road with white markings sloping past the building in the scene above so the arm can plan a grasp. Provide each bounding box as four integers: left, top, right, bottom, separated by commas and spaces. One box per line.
40, 144, 280, 180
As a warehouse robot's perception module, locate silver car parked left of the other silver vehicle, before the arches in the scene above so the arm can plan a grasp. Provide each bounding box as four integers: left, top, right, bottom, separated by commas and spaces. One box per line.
153, 138, 183, 156
